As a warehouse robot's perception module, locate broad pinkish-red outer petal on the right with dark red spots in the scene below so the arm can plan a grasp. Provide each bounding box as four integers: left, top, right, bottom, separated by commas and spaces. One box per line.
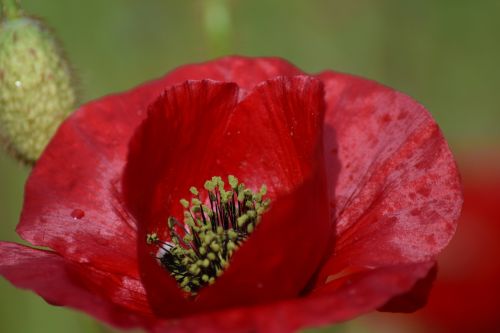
318, 72, 462, 285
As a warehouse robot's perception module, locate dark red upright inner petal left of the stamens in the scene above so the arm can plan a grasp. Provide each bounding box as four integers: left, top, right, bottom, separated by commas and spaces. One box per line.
123, 80, 242, 314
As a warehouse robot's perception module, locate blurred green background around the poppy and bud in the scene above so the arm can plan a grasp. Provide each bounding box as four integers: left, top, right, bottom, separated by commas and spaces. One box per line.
0, 0, 500, 333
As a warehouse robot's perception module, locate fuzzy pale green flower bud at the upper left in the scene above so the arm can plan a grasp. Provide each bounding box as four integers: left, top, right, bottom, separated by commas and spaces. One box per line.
0, 15, 76, 163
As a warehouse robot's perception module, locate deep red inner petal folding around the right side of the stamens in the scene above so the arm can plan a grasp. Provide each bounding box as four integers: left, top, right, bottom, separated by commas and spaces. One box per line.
198, 76, 332, 308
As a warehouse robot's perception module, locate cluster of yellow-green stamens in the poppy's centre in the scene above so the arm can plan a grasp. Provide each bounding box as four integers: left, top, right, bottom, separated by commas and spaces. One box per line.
147, 175, 270, 295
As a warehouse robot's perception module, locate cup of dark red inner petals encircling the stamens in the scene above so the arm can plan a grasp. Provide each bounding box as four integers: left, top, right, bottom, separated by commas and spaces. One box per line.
124, 77, 332, 316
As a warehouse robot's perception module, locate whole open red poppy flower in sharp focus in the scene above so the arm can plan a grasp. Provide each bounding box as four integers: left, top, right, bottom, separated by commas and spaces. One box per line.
0, 57, 462, 332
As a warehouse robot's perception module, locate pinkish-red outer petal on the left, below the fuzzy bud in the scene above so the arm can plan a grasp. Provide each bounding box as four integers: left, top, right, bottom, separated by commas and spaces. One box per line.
17, 80, 172, 276
